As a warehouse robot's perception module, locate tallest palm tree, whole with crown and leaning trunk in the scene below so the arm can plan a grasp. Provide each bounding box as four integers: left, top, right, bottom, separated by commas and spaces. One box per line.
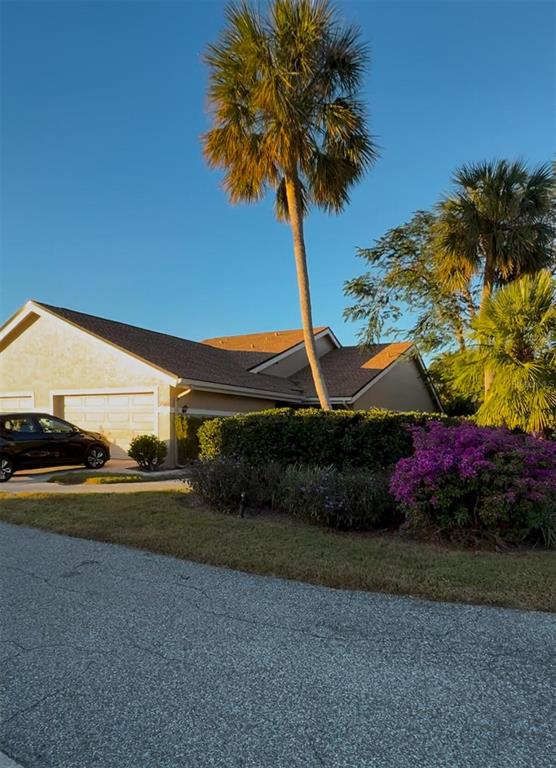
203, 0, 376, 409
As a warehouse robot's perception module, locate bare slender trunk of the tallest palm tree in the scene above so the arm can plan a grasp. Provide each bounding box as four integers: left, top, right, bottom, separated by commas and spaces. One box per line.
286, 175, 332, 411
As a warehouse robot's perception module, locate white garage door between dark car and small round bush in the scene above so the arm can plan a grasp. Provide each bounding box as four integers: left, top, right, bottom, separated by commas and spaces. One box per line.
63, 392, 157, 458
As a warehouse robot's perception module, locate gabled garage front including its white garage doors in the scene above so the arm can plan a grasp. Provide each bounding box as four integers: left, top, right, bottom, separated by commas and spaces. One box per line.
0, 302, 177, 466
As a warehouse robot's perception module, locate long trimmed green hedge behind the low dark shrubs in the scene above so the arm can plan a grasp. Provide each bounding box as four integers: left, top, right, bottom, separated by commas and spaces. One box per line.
198, 408, 457, 469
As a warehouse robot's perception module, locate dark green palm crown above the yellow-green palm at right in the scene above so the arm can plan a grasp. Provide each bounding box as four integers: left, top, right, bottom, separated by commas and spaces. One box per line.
435, 160, 555, 305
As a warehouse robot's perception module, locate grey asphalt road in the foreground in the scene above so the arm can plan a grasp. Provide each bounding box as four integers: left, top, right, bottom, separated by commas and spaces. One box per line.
0, 524, 556, 768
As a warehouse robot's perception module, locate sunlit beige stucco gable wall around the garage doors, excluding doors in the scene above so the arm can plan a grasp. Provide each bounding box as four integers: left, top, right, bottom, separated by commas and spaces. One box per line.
0, 315, 175, 464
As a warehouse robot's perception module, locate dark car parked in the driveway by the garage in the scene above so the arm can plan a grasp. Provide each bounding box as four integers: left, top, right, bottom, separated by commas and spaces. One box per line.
0, 413, 110, 483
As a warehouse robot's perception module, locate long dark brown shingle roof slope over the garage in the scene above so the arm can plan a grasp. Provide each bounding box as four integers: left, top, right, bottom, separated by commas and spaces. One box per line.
35, 302, 300, 397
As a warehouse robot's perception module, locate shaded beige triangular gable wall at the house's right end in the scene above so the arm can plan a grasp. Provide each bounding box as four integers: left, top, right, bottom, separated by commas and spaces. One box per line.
353, 359, 438, 412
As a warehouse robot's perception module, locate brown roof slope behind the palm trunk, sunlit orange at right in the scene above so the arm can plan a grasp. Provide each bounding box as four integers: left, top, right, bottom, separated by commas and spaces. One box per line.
290, 342, 412, 398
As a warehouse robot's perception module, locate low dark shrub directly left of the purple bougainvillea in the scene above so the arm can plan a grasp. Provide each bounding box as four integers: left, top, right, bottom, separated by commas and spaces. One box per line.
274, 465, 403, 531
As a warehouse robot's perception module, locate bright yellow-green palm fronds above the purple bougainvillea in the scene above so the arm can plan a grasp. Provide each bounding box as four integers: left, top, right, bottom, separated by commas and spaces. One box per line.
456, 270, 556, 433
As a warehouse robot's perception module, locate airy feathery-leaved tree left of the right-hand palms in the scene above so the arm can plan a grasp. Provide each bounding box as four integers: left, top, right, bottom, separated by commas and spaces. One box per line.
344, 211, 477, 352
